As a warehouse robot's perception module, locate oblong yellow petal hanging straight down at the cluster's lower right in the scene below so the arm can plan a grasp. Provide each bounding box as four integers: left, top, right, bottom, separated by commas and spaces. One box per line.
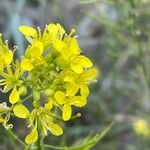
62, 104, 72, 121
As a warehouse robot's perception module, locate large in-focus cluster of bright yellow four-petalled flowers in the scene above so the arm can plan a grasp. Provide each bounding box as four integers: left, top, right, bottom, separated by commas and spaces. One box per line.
0, 23, 97, 144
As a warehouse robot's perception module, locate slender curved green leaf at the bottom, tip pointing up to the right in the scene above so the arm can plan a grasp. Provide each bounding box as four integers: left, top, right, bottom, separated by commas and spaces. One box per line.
44, 122, 114, 150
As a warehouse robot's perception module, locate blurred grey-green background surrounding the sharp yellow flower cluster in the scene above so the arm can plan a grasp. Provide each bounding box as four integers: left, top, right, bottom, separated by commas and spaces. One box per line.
0, 0, 150, 150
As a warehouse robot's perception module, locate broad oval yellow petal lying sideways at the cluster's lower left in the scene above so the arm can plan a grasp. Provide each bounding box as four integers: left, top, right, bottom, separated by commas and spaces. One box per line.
13, 104, 30, 118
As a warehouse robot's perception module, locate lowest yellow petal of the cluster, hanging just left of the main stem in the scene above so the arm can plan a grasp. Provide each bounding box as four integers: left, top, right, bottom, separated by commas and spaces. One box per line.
25, 128, 38, 144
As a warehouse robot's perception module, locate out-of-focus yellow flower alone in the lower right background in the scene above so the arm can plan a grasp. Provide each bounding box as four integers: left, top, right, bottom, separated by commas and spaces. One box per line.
134, 119, 150, 136
